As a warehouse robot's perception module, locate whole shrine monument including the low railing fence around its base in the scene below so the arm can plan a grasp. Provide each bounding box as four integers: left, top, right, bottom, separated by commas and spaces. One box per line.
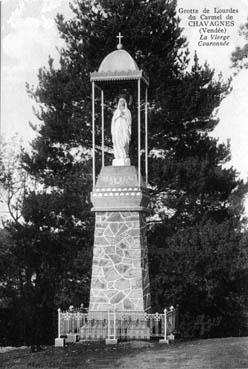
55, 34, 177, 346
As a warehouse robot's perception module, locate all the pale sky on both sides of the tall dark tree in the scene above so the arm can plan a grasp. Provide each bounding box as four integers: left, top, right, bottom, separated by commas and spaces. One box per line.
1, 0, 248, 179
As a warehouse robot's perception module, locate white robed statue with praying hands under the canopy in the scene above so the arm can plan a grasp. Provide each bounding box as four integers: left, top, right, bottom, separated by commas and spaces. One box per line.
111, 97, 132, 165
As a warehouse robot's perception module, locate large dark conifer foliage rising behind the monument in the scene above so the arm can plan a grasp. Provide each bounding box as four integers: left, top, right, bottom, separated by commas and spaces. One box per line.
4, 0, 248, 342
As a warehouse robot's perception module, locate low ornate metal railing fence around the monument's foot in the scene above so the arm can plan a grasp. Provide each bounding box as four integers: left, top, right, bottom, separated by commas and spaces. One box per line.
58, 307, 178, 340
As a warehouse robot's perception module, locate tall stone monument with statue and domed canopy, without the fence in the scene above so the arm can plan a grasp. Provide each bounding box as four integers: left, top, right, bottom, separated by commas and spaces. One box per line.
89, 34, 151, 312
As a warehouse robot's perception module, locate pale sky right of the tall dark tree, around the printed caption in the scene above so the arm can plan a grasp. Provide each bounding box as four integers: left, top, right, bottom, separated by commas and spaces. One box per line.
178, 0, 248, 180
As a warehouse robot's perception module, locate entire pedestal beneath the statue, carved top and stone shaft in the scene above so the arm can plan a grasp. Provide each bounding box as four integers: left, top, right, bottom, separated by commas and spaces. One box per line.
89, 166, 151, 312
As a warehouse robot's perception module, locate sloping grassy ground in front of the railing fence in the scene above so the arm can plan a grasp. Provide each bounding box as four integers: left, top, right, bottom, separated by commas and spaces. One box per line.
0, 337, 248, 369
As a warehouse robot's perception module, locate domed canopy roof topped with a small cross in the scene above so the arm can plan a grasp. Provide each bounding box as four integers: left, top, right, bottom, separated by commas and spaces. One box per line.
90, 33, 149, 86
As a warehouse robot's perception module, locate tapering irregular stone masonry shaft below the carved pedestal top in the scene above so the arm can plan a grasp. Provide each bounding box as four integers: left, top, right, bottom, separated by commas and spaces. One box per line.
89, 211, 151, 311
